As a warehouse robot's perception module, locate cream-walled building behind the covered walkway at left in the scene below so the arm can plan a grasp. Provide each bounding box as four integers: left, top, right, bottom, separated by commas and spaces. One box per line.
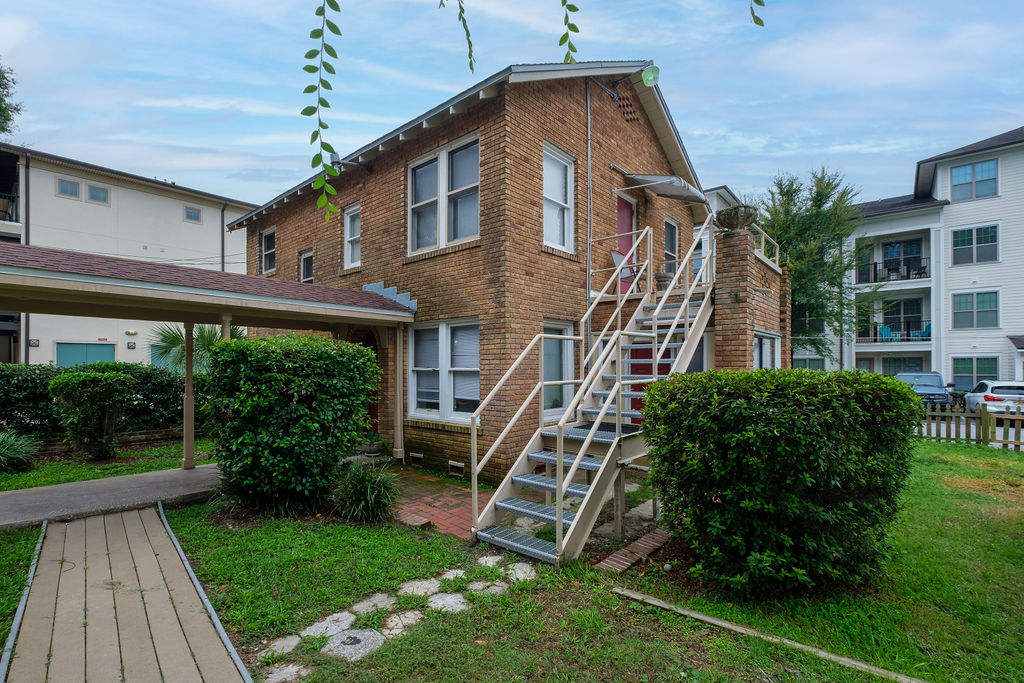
0, 142, 255, 366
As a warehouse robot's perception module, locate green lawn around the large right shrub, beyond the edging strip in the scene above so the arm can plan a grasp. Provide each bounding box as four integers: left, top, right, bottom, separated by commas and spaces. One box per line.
631, 443, 1024, 681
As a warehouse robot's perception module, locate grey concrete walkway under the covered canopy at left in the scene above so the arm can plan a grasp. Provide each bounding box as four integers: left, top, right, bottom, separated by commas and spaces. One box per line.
0, 465, 220, 529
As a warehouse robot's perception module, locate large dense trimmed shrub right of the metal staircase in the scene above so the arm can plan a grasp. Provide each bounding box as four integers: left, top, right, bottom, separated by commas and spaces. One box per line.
643, 370, 923, 595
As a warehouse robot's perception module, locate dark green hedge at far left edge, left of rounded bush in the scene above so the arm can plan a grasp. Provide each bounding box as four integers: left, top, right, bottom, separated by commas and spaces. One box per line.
0, 362, 67, 438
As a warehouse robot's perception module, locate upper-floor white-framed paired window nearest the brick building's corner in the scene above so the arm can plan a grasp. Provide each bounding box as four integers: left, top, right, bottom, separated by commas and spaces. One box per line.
409, 140, 480, 253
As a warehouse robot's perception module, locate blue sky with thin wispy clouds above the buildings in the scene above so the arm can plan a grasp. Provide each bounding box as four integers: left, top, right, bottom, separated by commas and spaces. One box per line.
0, 0, 1024, 204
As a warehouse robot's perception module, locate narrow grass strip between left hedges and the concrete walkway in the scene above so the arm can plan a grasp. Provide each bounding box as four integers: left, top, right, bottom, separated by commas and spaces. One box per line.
0, 439, 214, 490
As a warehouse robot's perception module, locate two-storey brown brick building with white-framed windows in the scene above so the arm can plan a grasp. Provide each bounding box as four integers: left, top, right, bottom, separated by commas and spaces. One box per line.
231, 61, 788, 561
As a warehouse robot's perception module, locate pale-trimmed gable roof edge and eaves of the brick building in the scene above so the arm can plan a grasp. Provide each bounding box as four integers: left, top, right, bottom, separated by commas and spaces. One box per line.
227, 60, 700, 229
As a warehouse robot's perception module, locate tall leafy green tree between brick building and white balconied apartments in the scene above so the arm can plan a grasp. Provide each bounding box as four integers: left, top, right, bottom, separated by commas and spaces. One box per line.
761, 168, 872, 359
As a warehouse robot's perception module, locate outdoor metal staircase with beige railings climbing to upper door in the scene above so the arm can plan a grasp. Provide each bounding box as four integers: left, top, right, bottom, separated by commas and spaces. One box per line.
470, 214, 714, 565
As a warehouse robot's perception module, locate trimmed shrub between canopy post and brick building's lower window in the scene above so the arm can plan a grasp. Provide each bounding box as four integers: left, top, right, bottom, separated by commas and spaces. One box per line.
206, 336, 380, 512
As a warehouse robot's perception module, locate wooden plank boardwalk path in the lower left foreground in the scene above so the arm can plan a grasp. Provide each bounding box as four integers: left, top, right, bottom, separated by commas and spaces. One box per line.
7, 508, 243, 683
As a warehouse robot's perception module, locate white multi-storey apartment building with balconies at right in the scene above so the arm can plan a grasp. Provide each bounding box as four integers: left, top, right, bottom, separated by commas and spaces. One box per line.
798, 127, 1024, 390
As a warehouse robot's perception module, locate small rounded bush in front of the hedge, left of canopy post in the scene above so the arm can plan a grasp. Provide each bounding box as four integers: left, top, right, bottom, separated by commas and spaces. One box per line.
50, 372, 136, 460
